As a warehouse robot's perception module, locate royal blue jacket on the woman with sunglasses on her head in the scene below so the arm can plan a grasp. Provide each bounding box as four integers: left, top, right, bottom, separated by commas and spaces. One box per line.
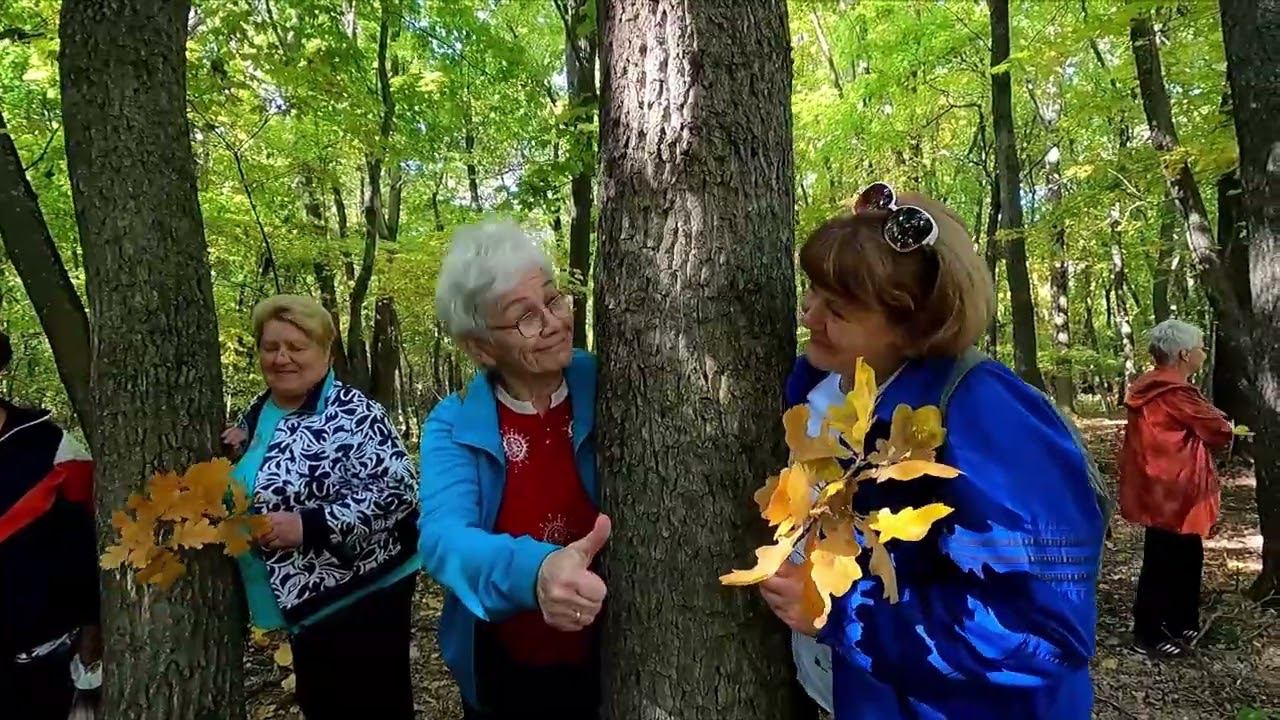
786, 357, 1103, 720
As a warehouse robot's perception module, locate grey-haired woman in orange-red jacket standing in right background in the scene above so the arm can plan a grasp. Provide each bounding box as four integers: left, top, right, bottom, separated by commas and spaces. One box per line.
1120, 320, 1231, 657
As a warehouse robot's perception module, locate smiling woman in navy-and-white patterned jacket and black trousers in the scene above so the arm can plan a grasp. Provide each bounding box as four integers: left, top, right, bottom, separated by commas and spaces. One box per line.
223, 295, 420, 720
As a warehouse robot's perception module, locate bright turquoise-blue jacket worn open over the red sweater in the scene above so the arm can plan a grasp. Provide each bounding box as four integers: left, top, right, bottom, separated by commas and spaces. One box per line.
419, 351, 599, 707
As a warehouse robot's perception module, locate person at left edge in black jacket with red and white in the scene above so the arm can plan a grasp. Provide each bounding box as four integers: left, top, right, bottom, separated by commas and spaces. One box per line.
0, 333, 101, 720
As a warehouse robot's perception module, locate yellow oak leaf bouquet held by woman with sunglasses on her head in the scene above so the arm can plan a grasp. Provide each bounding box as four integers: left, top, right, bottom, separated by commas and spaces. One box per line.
721, 359, 960, 628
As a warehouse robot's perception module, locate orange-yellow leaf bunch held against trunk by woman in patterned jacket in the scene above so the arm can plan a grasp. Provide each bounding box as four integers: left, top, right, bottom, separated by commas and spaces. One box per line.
101, 459, 268, 589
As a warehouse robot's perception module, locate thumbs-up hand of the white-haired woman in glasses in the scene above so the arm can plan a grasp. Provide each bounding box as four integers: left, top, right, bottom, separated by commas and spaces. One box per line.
538, 515, 613, 633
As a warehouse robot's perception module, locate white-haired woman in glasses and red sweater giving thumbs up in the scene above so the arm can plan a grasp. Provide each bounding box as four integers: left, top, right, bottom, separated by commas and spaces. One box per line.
420, 222, 609, 720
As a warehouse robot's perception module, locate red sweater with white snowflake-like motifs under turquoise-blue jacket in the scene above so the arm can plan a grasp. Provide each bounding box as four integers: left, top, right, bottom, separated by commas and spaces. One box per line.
494, 391, 598, 666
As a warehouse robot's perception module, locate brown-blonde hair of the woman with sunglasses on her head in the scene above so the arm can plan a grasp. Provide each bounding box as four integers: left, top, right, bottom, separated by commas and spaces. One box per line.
800, 192, 996, 357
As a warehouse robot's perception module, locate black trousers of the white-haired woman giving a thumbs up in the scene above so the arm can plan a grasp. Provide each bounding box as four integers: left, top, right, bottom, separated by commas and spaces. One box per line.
462, 628, 600, 720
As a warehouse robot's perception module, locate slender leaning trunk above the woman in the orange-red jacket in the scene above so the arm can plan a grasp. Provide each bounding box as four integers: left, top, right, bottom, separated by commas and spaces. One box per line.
1129, 14, 1248, 333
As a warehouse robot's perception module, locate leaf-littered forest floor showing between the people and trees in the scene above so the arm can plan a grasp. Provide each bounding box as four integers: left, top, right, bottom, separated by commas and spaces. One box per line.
246, 419, 1280, 720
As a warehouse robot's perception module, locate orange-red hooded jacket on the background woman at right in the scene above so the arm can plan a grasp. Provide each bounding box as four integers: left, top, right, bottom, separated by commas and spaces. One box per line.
1120, 368, 1231, 537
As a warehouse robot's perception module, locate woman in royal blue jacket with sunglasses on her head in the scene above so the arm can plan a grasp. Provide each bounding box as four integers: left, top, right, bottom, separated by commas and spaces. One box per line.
760, 183, 1105, 720
